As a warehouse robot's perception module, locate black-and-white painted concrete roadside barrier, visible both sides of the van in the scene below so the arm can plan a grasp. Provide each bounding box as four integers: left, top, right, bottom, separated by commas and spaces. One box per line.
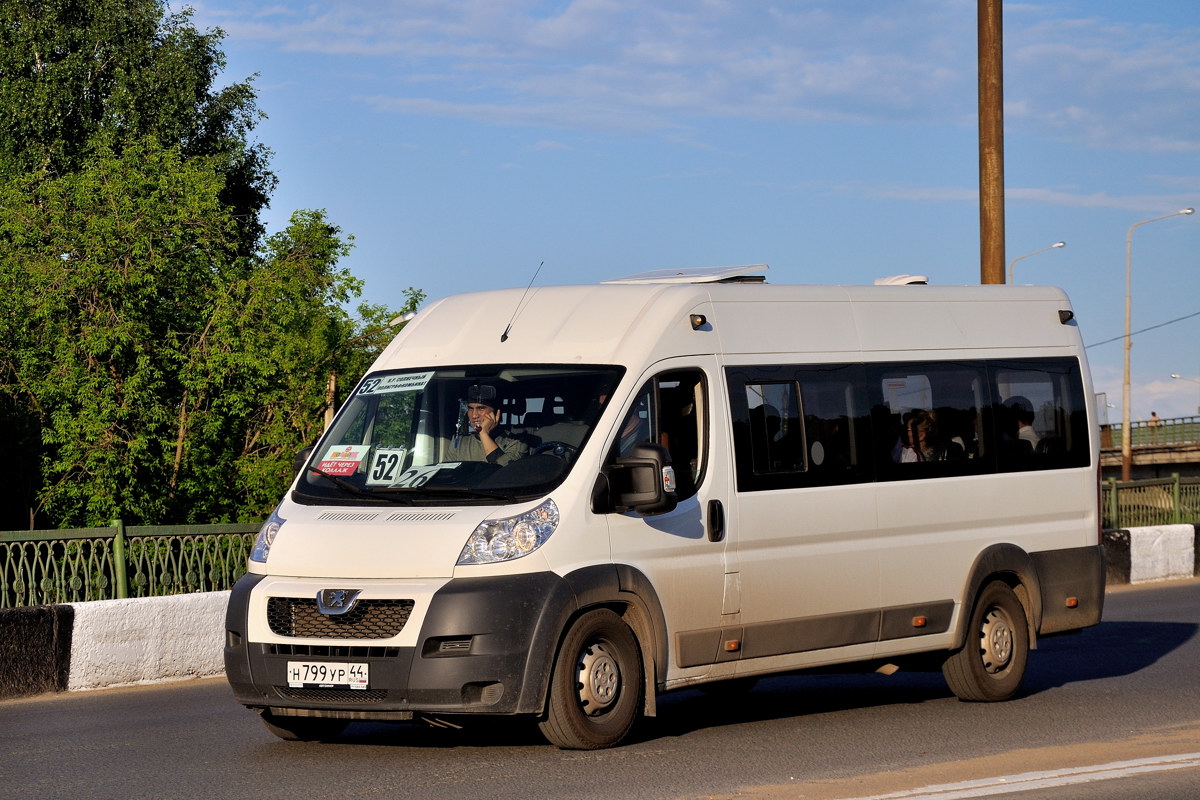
0, 525, 1200, 698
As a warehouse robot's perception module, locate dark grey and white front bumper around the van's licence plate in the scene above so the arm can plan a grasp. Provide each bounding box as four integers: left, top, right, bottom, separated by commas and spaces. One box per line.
224, 572, 576, 720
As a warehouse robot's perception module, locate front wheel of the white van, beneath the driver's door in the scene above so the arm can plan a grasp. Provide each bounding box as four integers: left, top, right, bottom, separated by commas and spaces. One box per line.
539, 608, 643, 750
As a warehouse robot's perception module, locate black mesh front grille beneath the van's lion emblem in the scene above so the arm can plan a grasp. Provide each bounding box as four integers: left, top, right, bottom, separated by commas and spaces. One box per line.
266, 597, 414, 639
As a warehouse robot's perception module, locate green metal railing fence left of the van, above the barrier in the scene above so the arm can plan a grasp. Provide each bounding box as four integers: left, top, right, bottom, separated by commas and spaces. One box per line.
0, 519, 260, 608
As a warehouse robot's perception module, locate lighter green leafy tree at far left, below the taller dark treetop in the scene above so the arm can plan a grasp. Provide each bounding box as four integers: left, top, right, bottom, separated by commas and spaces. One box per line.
0, 139, 242, 524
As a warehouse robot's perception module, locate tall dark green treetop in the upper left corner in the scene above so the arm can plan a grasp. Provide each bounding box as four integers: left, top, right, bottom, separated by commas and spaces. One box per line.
0, 0, 275, 247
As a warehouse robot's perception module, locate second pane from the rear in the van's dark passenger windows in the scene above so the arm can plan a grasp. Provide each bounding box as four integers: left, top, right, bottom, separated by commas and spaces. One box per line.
869, 362, 991, 480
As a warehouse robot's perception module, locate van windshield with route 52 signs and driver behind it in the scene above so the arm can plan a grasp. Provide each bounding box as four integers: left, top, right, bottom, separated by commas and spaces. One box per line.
294, 365, 624, 505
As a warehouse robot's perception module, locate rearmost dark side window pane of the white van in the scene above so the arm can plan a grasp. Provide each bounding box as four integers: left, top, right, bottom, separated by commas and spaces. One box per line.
992, 359, 1091, 471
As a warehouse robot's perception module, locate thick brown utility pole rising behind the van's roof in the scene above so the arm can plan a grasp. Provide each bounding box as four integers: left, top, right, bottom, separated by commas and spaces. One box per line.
979, 0, 1004, 283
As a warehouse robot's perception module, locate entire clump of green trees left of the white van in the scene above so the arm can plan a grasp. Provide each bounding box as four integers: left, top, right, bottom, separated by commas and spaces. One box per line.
0, 0, 422, 527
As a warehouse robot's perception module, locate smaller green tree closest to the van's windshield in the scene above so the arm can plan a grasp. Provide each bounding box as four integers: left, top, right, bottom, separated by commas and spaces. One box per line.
170, 211, 424, 521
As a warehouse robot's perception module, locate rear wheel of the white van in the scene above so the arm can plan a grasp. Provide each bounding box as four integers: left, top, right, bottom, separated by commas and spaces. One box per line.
942, 581, 1030, 703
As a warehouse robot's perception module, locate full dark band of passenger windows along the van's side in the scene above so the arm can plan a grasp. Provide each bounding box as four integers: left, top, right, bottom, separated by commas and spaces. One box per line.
726, 359, 1091, 492
